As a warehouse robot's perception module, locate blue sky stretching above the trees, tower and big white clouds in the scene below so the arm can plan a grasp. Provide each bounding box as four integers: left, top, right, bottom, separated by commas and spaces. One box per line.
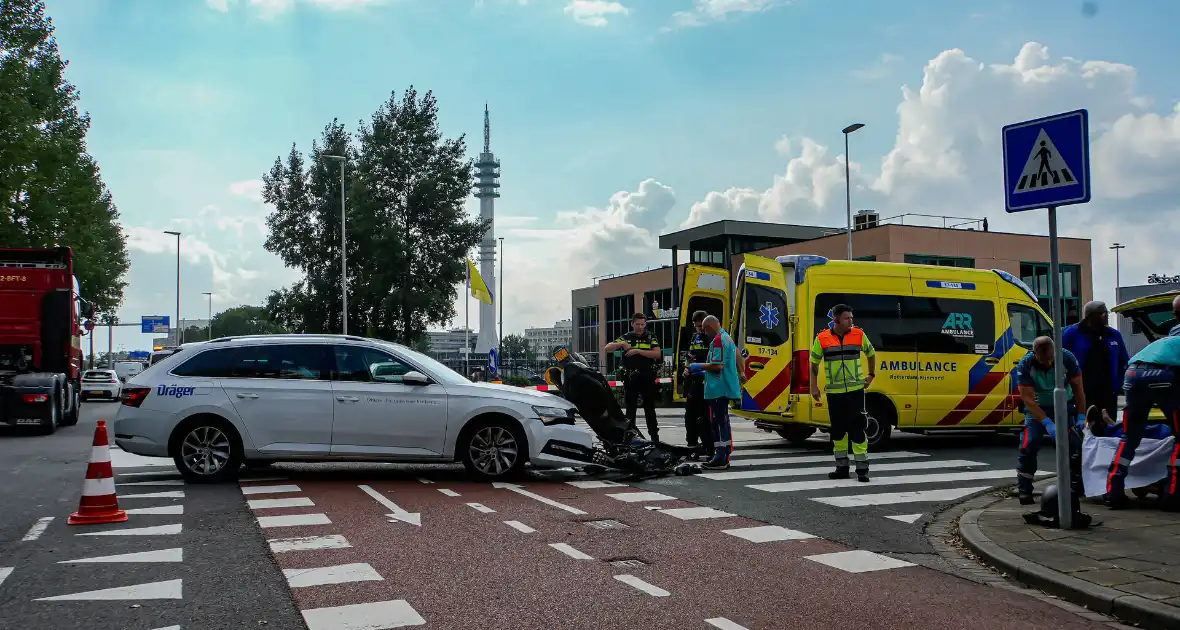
47, 0, 1180, 347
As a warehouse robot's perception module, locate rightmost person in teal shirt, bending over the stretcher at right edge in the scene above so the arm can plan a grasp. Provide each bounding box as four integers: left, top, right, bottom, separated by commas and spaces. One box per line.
1104, 296, 1180, 512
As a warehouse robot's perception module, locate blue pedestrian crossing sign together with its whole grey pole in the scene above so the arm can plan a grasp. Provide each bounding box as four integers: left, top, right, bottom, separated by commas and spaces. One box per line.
1003, 110, 1090, 530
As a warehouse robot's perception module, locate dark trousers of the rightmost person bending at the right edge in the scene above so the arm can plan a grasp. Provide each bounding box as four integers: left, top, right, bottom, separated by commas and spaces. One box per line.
1107, 363, 1180, 510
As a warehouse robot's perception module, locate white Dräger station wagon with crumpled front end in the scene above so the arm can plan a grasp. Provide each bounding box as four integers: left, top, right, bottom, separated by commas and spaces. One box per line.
114, 335, 594, 481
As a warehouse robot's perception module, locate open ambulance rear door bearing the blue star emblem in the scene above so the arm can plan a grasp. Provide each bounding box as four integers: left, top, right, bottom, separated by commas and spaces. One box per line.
732, 254, 794, 420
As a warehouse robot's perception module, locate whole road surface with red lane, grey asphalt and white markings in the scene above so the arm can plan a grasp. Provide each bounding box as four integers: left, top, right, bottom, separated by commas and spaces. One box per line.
0, 402, 1101, 630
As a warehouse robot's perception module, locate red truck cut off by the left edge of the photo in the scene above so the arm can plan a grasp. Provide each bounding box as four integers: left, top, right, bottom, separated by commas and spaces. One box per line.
0, 248, 94, 433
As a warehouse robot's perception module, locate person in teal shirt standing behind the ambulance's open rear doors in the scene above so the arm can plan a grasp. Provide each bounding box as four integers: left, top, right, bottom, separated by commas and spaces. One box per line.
689, 315, 741, 470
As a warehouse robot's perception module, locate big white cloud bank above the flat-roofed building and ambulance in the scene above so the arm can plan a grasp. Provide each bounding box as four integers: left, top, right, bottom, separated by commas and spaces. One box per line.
476, 42, 1180, 337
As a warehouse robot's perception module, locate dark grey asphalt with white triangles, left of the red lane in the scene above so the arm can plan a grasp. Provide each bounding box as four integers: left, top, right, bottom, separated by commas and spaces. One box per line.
0, 402, 302, 630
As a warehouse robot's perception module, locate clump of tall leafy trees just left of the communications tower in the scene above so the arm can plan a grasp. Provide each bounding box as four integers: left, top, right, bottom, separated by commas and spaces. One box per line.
263, 86, 489, 344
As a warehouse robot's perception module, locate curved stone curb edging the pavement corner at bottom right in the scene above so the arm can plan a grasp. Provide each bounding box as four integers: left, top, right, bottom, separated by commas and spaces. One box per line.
925, 484, 1142, 630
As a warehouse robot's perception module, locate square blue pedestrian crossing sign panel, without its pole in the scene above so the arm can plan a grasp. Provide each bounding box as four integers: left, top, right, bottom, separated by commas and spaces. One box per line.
1003, 110, 1090, 212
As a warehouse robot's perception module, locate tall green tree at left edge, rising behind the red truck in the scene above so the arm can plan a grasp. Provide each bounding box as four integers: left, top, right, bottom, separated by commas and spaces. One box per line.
0, 0, 130, 313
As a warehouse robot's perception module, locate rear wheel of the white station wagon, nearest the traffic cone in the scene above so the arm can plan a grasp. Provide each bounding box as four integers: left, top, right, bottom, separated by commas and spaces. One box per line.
171, 415, 243, 484
